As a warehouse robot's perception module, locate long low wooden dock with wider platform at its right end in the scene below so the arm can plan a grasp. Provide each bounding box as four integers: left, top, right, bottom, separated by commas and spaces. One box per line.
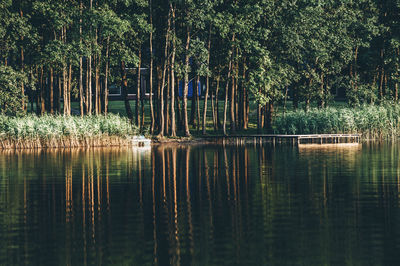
208, 134, 361, 145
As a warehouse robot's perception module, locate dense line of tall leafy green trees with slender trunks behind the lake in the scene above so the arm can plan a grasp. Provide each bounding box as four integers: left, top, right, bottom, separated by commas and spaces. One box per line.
0, 0, 400, 136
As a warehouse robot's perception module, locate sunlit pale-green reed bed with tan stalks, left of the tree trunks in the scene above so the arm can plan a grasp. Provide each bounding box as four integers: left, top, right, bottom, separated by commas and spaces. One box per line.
0, 114, 139, 149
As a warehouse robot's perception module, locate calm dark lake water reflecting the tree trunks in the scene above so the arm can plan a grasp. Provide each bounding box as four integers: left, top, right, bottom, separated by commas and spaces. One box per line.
0, 144, 400, 265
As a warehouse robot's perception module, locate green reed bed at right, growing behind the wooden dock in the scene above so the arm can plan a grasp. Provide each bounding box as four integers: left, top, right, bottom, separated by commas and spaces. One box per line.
274, 103, 400, 139
